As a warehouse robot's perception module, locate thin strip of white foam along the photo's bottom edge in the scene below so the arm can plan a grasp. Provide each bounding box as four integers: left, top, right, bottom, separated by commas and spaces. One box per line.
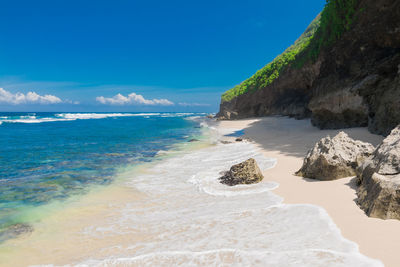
77, 249, 382, 267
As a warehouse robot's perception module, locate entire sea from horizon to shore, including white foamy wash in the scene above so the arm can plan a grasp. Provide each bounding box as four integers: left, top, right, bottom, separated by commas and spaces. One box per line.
0, 113, 382, 267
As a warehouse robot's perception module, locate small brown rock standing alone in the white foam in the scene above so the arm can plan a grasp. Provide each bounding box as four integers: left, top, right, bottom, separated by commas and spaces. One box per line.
219, 158, 264, 186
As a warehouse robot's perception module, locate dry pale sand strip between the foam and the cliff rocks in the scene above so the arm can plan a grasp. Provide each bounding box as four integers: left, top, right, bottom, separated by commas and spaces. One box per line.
219, 117, 400, 267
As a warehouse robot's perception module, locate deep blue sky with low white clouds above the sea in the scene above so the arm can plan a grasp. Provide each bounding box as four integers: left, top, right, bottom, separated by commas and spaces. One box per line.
0, 0, 325, 112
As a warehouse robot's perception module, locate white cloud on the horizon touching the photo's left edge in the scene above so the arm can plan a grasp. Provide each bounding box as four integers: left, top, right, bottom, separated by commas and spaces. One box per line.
0, 88, 62, 105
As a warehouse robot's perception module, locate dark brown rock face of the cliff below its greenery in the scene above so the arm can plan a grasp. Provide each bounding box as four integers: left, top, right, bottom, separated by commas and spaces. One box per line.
218, 0, 400, 135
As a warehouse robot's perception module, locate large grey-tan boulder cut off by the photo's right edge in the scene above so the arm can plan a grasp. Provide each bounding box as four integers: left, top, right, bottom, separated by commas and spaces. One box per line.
357, 125, 400, 219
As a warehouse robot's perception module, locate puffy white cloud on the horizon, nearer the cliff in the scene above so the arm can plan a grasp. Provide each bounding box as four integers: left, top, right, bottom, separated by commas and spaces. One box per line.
96, 93, 174, 106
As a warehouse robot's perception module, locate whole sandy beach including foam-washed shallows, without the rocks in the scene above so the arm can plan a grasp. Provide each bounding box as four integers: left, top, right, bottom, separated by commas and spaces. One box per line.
0, 117, 400, 267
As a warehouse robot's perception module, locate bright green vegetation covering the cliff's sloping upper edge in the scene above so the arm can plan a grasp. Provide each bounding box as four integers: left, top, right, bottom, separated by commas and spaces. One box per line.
221, 0, 359, 102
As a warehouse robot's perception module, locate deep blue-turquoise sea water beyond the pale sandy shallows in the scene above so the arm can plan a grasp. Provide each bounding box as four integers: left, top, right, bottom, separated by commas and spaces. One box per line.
0, 113, 204, 241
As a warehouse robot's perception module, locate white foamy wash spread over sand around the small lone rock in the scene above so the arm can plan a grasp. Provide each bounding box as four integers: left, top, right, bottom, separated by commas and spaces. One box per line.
70, 126, 383, 267
